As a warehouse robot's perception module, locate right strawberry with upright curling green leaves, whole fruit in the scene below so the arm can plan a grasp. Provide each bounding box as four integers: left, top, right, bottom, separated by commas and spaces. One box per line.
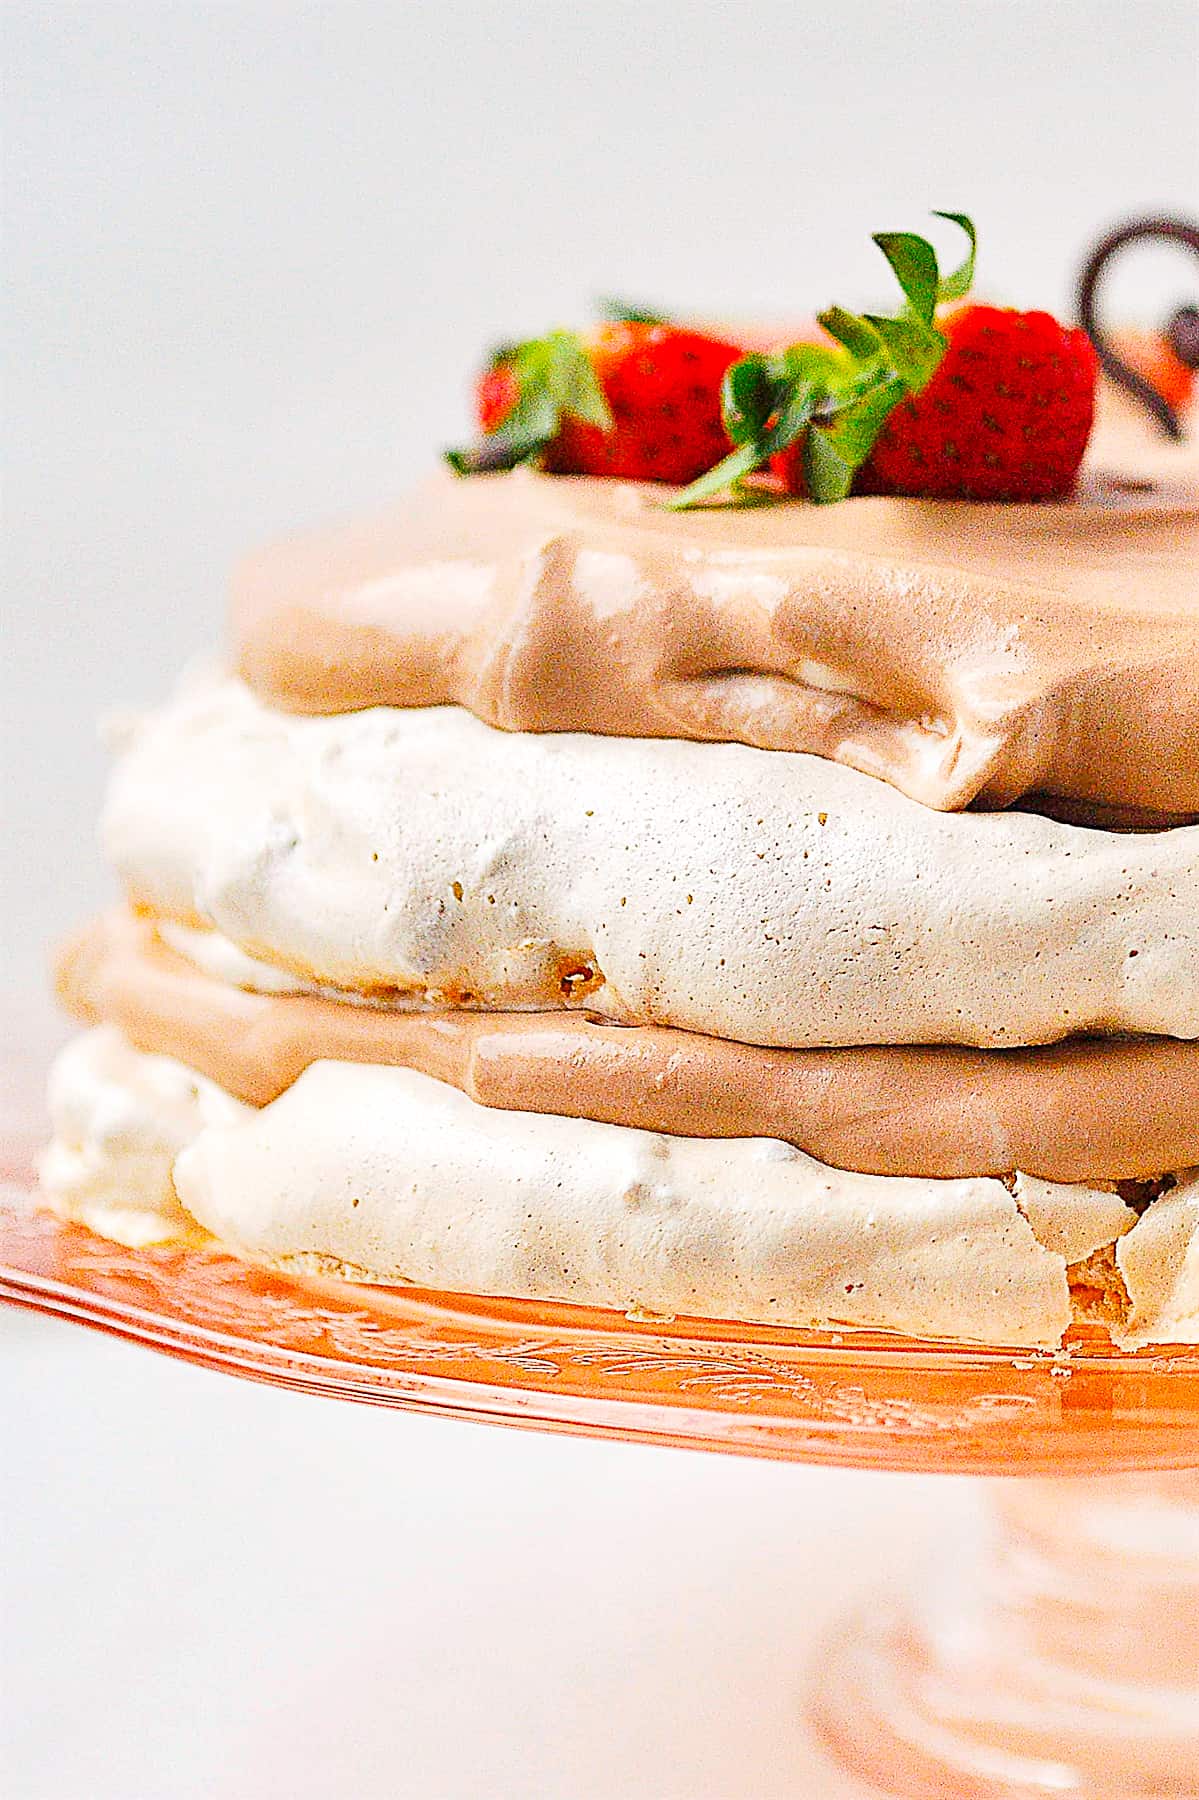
668, 212, 1098, 508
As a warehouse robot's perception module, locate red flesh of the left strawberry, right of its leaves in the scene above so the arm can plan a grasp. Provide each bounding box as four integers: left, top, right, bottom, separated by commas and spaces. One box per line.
547, 324, 742, 482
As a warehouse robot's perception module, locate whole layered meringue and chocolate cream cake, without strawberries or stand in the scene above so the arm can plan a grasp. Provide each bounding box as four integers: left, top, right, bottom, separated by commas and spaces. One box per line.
41, 250, 1199, 1346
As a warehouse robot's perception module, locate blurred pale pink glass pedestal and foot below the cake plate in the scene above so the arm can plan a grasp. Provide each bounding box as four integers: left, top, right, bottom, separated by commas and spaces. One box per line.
810, 1471, 1199, 1800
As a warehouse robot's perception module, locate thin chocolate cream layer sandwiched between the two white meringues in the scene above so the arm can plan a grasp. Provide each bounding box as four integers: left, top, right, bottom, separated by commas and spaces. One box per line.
58, 913, 1199, 1183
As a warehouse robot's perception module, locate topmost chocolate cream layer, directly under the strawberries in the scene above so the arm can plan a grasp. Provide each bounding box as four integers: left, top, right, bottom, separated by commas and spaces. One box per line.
234, 454, 1199, 823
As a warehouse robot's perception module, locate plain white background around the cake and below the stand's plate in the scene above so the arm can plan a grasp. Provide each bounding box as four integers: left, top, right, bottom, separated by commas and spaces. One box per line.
0, 0, 1199, 1800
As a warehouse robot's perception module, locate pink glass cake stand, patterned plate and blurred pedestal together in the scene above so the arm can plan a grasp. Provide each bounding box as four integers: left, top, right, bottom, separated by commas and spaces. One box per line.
0, 1130, 1199, 1800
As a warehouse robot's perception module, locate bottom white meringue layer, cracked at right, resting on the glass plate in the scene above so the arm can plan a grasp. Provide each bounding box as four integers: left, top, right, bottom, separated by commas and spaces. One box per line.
43, 1028, 1199, 1346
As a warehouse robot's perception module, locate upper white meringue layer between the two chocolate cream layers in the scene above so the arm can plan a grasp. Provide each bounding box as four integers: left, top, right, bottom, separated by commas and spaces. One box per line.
104, 680, 1199, 1048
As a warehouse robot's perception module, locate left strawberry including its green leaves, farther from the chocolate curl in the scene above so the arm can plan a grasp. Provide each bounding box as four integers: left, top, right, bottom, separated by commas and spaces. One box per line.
448, 317, 742, 482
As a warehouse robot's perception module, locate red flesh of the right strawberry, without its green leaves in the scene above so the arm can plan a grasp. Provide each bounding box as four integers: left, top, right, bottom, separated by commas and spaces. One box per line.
855, 306, 1098, 500
